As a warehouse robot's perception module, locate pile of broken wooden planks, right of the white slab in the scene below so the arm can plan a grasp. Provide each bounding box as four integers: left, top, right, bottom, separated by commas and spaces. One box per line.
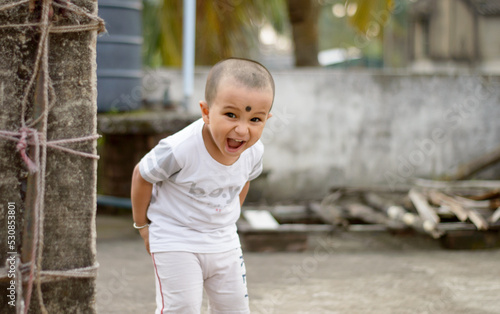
311, 180, 500, 239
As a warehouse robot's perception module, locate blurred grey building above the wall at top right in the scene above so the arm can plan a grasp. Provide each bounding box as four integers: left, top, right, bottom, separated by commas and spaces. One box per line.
409, 0, 500, 75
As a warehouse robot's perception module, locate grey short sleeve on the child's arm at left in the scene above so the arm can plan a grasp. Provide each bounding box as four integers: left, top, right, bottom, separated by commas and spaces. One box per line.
139, 139, 181, 183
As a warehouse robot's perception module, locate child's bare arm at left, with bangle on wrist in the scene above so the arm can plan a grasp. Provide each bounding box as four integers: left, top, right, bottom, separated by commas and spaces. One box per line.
130, 165, 153, 254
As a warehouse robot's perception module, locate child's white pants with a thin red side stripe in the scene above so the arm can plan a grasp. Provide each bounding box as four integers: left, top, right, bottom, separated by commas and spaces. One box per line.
151, 248, 250, 314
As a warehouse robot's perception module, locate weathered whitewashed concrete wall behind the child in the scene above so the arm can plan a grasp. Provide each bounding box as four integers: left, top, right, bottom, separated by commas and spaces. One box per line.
146, 69, 500, 202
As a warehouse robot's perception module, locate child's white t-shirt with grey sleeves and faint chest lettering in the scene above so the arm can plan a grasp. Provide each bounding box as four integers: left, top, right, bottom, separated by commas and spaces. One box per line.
139, 119, 264, 253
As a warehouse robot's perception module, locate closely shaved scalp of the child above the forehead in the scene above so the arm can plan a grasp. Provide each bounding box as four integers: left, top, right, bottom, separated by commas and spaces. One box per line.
205, 58, 274, 106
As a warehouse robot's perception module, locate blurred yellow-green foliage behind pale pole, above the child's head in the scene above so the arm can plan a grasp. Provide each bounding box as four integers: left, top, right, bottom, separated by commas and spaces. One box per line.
143, 0, 288, 67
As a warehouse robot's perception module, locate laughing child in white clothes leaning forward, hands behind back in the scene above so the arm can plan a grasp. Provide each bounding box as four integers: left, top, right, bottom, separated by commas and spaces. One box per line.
131, 58, 274, 314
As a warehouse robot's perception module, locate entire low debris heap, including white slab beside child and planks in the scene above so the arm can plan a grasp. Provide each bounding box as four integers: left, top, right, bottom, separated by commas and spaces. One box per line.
238, 180, 500, 251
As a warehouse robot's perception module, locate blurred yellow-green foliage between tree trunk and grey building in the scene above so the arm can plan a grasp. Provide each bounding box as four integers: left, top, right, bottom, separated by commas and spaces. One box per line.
319, 0, 409, 67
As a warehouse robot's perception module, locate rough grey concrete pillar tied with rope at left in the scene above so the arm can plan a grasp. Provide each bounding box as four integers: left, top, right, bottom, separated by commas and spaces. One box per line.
0, 0, 101, 313
